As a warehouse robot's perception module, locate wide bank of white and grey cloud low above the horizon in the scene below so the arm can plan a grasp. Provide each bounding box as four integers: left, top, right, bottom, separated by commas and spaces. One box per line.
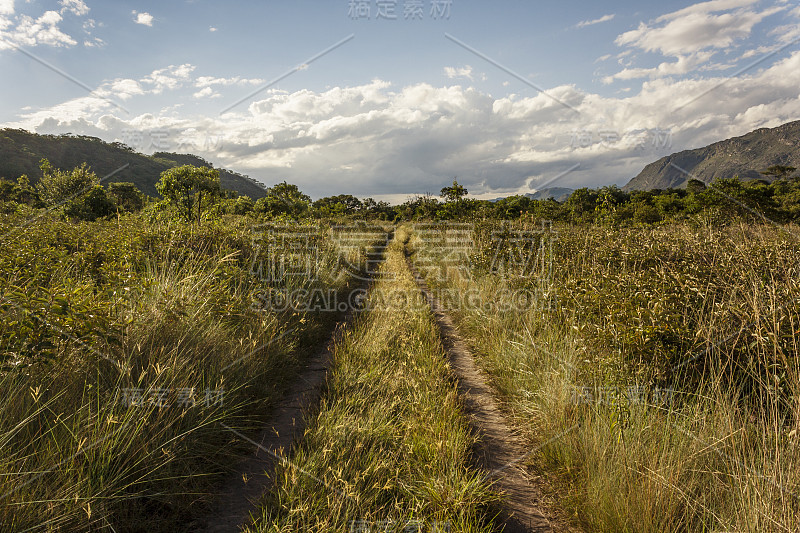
5, 50, 800, 196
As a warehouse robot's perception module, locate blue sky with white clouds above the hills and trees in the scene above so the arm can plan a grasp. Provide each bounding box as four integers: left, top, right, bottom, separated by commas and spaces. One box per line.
0, 0, 800, 202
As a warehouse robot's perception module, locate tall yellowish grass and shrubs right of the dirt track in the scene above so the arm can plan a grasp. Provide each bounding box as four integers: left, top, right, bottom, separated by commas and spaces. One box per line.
416, 220, 800, 532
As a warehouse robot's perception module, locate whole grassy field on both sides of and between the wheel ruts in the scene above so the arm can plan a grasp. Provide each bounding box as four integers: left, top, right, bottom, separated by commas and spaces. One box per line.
0, 205, 800, 533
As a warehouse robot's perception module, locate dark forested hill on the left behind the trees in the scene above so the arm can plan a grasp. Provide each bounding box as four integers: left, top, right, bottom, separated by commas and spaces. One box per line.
0, 129, 266, 200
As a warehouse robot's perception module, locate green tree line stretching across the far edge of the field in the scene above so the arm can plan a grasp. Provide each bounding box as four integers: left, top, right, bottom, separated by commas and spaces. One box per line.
0, 159, 800, 225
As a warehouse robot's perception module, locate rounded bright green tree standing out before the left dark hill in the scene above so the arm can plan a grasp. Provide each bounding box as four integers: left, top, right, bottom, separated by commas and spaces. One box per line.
156, 165, 221, 222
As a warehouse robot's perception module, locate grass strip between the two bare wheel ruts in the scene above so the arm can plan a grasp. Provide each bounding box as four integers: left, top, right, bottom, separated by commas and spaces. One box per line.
250, 229, 497, 532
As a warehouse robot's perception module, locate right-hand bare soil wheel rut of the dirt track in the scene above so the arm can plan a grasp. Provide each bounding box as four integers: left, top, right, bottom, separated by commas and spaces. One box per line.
408, 260, 553, 533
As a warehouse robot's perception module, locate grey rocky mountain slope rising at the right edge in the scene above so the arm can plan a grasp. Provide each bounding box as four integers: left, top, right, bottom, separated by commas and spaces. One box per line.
623, 120, 800, 191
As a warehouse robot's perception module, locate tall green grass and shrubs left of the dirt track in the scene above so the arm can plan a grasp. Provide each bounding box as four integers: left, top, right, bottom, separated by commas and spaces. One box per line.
0, 217, 363, 533
